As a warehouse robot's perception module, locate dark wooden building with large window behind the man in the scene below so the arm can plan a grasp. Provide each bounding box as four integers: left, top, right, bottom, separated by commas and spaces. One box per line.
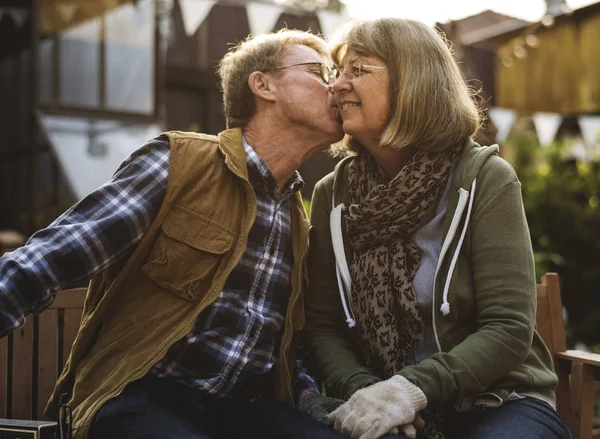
0, 0, 341, 234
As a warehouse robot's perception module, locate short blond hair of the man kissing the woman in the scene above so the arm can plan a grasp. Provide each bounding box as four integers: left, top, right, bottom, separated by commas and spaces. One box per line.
219, 29, 329, 128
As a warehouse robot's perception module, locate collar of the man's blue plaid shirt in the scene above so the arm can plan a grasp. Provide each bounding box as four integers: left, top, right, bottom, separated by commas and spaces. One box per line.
242, 136, 304, 200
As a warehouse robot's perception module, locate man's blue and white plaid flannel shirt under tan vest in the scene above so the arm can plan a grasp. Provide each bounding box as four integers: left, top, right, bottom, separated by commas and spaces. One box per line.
0, 136, 318, 398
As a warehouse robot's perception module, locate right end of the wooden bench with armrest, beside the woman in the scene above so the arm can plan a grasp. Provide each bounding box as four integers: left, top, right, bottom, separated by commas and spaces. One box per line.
536, 273, 600, 439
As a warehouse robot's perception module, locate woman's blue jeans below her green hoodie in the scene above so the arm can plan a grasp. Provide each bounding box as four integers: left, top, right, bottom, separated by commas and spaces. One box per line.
381, 398, 571, 439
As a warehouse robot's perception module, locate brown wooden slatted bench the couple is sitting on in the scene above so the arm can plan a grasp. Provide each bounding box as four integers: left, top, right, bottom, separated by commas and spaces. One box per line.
0, 273, 600, 439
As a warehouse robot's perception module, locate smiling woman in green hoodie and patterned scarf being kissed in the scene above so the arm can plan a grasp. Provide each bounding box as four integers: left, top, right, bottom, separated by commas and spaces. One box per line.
306, 19, 570, 439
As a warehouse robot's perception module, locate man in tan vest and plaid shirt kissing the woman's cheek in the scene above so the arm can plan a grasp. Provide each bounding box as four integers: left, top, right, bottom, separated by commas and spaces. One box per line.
0, 31, 343, 439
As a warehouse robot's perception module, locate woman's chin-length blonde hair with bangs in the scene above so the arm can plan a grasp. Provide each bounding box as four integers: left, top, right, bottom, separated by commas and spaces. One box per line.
331, 18, 481, 155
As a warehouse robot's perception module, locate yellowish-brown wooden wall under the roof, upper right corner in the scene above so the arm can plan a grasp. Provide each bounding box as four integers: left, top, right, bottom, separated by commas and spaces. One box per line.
495, 3, 600, 115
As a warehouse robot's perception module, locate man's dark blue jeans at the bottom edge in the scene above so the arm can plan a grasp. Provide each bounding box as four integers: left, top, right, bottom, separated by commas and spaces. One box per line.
89, 378, 346, 439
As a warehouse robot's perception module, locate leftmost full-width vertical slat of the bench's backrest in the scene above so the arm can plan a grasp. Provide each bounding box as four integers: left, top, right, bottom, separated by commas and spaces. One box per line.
12, 317, 34, 419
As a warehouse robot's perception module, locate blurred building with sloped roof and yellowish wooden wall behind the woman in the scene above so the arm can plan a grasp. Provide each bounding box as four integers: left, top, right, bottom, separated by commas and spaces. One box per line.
446, 2, 600, 116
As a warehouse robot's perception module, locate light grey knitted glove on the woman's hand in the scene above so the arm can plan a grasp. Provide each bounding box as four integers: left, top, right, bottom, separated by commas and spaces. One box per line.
328, 375, 427, 439
